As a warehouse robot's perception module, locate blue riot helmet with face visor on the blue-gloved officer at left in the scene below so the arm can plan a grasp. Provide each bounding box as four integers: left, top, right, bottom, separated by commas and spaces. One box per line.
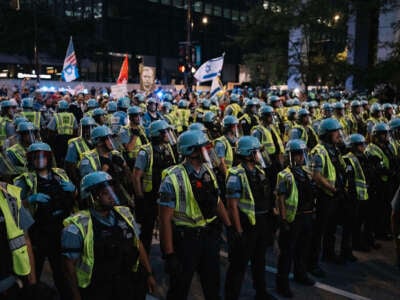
26, 142, 54, 170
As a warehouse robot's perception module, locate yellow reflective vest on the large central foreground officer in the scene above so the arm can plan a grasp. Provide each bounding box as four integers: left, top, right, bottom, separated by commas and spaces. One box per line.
162, 164, 218, 227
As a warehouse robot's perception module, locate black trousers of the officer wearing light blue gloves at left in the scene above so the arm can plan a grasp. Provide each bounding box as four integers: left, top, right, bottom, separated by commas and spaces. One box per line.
31, 229, 68, 299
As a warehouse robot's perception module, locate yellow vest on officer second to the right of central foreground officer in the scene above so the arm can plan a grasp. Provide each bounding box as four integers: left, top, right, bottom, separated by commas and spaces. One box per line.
276, 167, 299, 223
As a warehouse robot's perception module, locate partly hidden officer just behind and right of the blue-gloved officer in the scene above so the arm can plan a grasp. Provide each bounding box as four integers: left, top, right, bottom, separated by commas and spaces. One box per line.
65, 117, 97, 185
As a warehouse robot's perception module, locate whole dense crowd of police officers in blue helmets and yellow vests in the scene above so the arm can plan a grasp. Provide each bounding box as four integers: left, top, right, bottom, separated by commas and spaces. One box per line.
0, 89, 400, 300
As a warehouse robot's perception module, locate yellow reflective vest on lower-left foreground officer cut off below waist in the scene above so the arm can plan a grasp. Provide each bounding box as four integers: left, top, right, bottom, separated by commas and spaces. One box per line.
63, 206, 139, 288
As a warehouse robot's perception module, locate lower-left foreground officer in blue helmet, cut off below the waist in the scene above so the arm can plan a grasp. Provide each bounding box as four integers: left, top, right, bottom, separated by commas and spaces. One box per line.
62, 171, 155, 300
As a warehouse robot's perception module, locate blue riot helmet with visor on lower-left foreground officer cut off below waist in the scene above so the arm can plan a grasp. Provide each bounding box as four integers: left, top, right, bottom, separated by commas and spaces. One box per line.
81, 171, 119, 206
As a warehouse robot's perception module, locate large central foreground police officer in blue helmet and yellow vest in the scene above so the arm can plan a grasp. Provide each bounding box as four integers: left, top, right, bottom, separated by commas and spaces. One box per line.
159, 130, 231, 300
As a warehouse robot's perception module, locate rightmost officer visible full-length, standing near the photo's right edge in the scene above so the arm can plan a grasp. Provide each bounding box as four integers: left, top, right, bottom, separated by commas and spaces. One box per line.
365, 122, 397, 240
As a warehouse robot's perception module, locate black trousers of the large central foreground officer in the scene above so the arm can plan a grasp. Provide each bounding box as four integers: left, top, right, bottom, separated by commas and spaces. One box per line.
167, 227, 220, 300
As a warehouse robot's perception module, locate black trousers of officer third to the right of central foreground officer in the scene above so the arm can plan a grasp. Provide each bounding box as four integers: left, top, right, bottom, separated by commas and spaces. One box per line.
309, 192, 338, 268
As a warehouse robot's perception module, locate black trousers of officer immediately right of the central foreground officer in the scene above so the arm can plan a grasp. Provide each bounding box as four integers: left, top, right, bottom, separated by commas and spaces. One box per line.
225, 214, 272, 300
